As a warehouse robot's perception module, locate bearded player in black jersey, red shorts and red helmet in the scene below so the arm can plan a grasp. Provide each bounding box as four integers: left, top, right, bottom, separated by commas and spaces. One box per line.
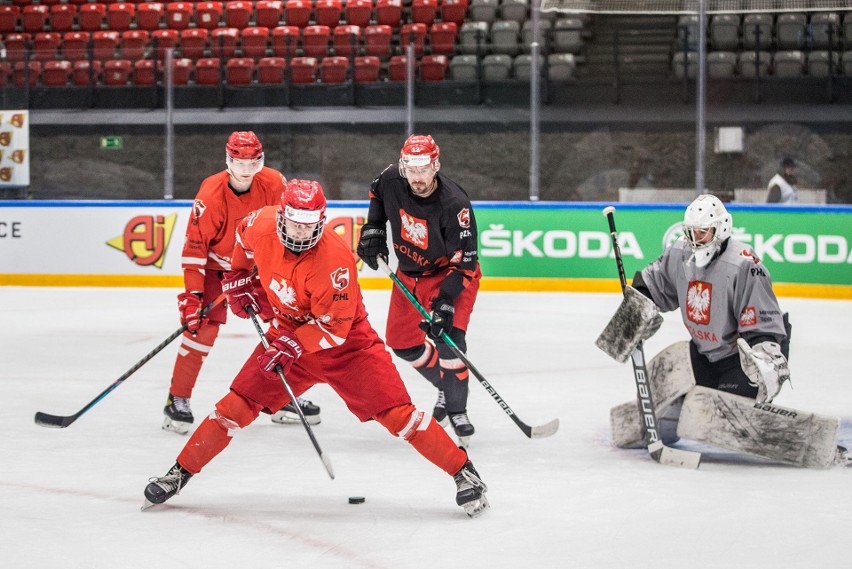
358, 135, 482, 445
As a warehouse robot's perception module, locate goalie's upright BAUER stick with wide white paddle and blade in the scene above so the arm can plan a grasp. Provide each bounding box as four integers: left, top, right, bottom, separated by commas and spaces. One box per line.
603, 206, 701, 468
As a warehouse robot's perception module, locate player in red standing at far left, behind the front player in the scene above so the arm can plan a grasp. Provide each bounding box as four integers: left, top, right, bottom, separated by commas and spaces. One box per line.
163, 131, 320, 434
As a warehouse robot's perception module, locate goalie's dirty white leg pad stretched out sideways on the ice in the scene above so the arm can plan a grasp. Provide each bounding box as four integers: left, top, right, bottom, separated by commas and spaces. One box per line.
677, 386, 840, 468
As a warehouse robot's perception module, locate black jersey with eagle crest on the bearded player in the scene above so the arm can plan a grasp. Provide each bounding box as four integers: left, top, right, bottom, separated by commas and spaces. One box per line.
367, 165, 478, 297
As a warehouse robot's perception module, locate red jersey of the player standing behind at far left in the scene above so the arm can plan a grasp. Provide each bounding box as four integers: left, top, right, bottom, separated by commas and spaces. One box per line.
181, 168, 284, 292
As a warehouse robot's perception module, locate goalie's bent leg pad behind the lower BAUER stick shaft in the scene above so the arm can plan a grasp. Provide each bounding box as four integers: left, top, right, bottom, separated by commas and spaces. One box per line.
610, 341, 695, 448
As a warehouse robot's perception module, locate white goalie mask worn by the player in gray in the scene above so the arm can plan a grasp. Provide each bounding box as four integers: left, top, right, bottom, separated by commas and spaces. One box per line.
683, 194, 733, 267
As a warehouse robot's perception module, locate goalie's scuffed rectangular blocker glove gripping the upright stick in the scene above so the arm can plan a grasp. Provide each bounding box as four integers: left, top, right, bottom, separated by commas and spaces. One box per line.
595, 286, 663, 363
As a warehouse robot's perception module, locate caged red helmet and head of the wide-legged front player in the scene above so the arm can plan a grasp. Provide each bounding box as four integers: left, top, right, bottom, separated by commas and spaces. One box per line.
278, 176, 326, 253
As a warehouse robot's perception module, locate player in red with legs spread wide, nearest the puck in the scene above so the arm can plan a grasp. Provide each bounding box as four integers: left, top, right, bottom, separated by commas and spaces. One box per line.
145, 180, 488, 516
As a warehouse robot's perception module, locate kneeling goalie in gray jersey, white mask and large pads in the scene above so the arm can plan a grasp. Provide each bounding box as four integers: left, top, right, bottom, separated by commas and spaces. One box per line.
597, 194, 846, 468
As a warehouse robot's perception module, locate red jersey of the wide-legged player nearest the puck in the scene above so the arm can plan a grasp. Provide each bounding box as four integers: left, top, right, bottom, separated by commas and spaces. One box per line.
231, 206, 367, 353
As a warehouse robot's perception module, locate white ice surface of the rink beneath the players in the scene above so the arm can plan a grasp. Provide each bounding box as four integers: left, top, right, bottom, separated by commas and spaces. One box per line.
0, 287, 852, 569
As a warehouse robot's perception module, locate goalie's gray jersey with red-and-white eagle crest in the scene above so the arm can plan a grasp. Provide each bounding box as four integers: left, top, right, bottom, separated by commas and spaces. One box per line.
642, 239, 786, 362
